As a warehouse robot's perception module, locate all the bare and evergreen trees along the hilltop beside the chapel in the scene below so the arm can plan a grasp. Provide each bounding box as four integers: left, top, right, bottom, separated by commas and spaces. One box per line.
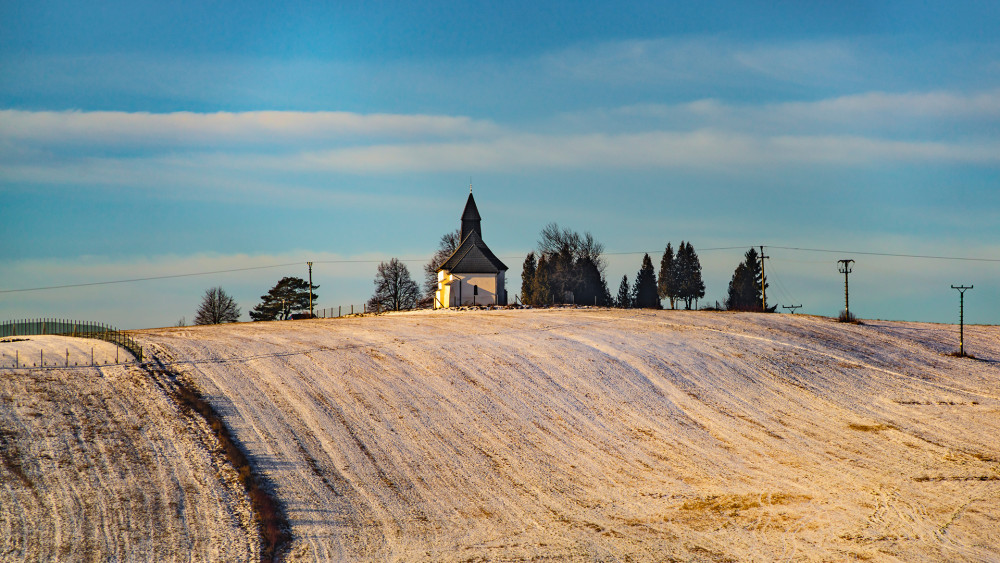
189, 230, 777, 324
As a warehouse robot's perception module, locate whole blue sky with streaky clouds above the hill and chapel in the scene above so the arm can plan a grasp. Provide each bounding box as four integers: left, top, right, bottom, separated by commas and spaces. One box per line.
0, 1, 1000, 328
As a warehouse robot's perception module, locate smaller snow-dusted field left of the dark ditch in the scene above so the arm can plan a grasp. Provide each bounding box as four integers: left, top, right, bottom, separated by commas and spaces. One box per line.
0, 336, 258, 561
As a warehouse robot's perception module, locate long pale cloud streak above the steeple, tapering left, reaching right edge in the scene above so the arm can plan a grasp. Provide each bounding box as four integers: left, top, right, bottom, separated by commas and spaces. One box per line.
278, 130, 1000, 173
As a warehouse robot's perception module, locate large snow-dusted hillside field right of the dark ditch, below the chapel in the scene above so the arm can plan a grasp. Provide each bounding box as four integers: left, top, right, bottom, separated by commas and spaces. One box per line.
129, 309, 1000, 561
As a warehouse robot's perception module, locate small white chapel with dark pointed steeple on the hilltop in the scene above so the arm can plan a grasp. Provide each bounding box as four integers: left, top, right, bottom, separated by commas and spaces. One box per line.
434, 193, 507, 309
